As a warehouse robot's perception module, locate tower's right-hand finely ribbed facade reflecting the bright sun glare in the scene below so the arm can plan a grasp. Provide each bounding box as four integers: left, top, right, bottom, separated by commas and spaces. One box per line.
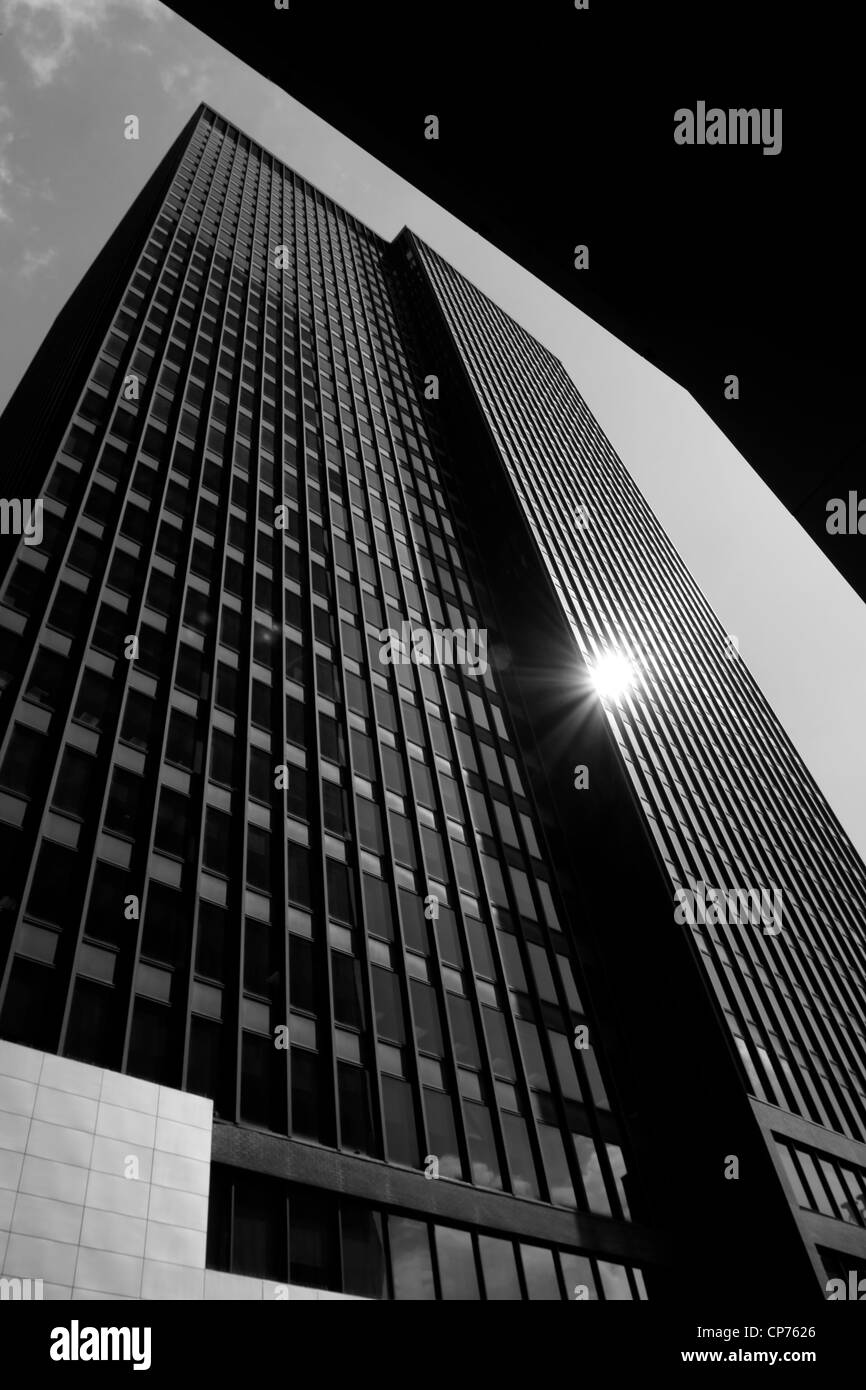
400, 232, 866, 1277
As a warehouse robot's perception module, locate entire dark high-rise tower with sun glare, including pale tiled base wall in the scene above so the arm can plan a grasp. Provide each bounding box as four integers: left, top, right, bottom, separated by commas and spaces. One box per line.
0, 107, 866, 1300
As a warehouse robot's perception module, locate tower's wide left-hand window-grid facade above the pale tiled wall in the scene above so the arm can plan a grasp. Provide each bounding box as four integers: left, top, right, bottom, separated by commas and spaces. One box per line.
0, 107, 656, 1300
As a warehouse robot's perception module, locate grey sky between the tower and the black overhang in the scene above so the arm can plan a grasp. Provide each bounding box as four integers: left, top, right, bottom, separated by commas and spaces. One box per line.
0, 0, 866, 858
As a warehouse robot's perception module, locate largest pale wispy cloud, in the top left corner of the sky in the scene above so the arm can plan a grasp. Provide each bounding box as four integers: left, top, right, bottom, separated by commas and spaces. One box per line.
0, 0, 165, 86
